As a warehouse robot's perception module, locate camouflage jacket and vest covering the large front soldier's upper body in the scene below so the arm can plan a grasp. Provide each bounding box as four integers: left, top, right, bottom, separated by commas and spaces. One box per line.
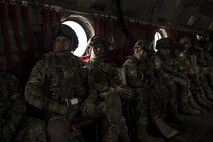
25, 52, 94, 116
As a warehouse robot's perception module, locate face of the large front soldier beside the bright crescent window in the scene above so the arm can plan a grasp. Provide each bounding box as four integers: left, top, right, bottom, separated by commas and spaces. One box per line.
53, 36, 71, 52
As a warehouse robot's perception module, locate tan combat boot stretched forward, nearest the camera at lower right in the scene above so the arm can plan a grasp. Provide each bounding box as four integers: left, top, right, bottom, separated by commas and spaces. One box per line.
154, 117, 178, 139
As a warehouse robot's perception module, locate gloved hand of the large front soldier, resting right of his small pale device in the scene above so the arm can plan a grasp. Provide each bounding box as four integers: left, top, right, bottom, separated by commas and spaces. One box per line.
81, 100, 95, 117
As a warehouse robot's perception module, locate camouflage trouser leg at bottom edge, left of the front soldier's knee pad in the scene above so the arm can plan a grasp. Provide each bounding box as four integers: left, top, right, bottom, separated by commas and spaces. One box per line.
15, 118, 47, 142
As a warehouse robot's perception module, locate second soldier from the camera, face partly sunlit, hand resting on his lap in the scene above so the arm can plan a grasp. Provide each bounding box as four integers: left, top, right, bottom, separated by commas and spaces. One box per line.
88, 36, 130, 142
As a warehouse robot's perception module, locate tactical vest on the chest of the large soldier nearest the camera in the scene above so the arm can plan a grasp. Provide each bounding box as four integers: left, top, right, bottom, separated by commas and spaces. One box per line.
45, 53, 87, 111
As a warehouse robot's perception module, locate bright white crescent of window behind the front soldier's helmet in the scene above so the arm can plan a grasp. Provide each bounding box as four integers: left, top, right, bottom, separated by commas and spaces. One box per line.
63, 20, 88, 57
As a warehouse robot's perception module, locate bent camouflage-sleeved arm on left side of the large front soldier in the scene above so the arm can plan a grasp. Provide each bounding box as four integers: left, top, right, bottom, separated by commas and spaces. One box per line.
25, 59, 68, 115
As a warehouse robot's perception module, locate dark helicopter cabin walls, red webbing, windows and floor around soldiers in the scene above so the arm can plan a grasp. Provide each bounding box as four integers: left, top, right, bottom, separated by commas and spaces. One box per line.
0, 0, 213, 142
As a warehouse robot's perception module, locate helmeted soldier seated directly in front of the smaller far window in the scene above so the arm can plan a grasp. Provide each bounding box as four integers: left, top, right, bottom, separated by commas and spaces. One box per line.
151, 38, 200, 114
